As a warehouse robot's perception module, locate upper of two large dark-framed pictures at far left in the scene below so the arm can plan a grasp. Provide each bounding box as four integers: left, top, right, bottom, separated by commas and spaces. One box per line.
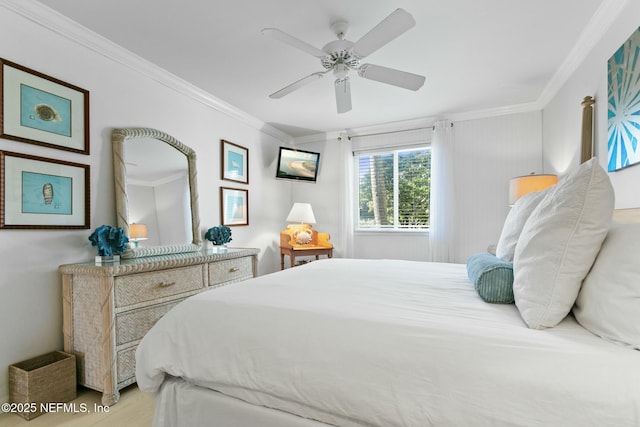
0, 58, 89, 154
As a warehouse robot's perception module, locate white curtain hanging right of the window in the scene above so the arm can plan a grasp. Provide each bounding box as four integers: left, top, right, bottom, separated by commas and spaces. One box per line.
429, 120, 456, 262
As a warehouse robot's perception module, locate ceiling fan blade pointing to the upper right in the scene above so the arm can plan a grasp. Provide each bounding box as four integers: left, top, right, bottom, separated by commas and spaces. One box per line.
351, 9, 416, 58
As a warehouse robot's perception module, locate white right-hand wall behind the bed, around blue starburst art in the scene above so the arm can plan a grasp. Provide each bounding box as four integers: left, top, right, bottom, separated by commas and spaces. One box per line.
543, 1, 640, 208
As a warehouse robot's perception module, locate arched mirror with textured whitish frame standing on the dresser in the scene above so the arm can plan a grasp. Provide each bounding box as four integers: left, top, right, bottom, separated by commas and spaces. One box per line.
111, 128, 202, 258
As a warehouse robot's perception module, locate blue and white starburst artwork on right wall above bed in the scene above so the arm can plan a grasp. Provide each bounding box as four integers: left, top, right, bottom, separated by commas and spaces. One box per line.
607, 28, 640, 172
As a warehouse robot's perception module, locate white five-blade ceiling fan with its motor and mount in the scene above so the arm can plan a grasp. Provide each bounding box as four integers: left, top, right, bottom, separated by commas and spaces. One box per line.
262, 9, 425, 113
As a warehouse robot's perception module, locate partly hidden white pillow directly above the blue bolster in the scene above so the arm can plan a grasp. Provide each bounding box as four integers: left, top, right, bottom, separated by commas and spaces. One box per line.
496, 189, 549, 262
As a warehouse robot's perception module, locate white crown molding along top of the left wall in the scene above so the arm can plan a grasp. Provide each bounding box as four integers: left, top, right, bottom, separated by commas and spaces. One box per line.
0, 0, 291, 142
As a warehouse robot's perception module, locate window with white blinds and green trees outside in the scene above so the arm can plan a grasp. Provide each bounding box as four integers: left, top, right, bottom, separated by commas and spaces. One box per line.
355, 146, 431, 230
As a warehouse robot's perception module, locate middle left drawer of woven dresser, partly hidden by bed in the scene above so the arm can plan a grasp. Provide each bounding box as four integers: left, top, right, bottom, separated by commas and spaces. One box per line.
116, 299, 182, 345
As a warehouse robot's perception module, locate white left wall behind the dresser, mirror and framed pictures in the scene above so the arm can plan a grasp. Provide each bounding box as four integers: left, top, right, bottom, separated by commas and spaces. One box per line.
0, 3, 291, 402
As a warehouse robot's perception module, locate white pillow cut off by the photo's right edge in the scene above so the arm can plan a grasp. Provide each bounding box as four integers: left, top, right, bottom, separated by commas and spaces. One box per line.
573, 223, 640, 350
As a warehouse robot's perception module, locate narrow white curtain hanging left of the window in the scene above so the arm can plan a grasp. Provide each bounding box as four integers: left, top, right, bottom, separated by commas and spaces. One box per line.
340, 134, 354, 258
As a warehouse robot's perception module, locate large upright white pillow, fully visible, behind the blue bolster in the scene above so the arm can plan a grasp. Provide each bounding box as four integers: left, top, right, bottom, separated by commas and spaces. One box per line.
513, 157, 614, 329
